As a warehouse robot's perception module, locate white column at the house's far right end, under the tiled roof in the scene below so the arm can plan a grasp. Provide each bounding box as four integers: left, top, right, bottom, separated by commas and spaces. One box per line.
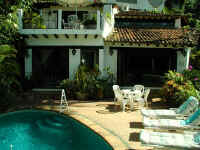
177, 48, 191, 72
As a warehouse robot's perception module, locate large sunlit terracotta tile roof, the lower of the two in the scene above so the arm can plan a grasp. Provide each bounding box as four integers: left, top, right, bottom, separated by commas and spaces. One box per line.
104, 27, 197, 47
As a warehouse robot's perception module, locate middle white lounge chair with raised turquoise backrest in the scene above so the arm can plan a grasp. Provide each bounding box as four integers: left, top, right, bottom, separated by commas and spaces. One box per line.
143, 109, 200, 130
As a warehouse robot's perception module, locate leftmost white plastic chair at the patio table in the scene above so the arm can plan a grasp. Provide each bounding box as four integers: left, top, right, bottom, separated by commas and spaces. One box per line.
113, 85, 129, 112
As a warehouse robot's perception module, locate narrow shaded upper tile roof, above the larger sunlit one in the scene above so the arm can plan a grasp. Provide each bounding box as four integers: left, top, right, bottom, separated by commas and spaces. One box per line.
115, 10, 185, 19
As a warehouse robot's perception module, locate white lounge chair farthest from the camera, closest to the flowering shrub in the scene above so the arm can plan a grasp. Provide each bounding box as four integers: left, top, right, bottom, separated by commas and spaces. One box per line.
141, 96, 199, 118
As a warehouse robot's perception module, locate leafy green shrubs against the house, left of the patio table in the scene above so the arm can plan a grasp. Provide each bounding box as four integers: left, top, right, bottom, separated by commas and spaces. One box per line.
60, 64, 114, 99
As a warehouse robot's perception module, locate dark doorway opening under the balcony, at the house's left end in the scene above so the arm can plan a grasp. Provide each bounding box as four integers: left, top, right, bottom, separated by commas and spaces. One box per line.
32, 47, 69, 88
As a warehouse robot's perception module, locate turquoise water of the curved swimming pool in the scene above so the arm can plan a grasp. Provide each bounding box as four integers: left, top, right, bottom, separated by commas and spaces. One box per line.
0, 110, 112, 150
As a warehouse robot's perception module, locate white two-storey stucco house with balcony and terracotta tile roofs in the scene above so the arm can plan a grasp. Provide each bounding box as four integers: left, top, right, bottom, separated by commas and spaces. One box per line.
19, 0, 197, 88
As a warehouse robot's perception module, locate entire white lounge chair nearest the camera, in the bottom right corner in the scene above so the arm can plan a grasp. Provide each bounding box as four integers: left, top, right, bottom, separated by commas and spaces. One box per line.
140, 130, 200, 150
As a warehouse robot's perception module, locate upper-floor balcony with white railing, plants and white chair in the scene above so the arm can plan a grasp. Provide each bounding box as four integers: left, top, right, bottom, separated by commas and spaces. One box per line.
19, 10, 102, 35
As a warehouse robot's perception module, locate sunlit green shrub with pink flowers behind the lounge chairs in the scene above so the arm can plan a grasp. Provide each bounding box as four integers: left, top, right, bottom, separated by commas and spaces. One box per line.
161, 71, 200, 105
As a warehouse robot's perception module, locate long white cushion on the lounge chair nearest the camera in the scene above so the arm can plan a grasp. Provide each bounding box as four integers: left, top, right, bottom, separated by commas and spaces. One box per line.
140, 130, 200, 149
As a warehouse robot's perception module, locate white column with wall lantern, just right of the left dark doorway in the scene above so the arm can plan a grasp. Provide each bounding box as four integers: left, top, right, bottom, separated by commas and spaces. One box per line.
69, 49, 81, 79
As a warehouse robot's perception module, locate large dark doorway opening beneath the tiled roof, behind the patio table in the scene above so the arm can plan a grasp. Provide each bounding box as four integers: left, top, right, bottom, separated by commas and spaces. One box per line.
118, 48, 177, 86
